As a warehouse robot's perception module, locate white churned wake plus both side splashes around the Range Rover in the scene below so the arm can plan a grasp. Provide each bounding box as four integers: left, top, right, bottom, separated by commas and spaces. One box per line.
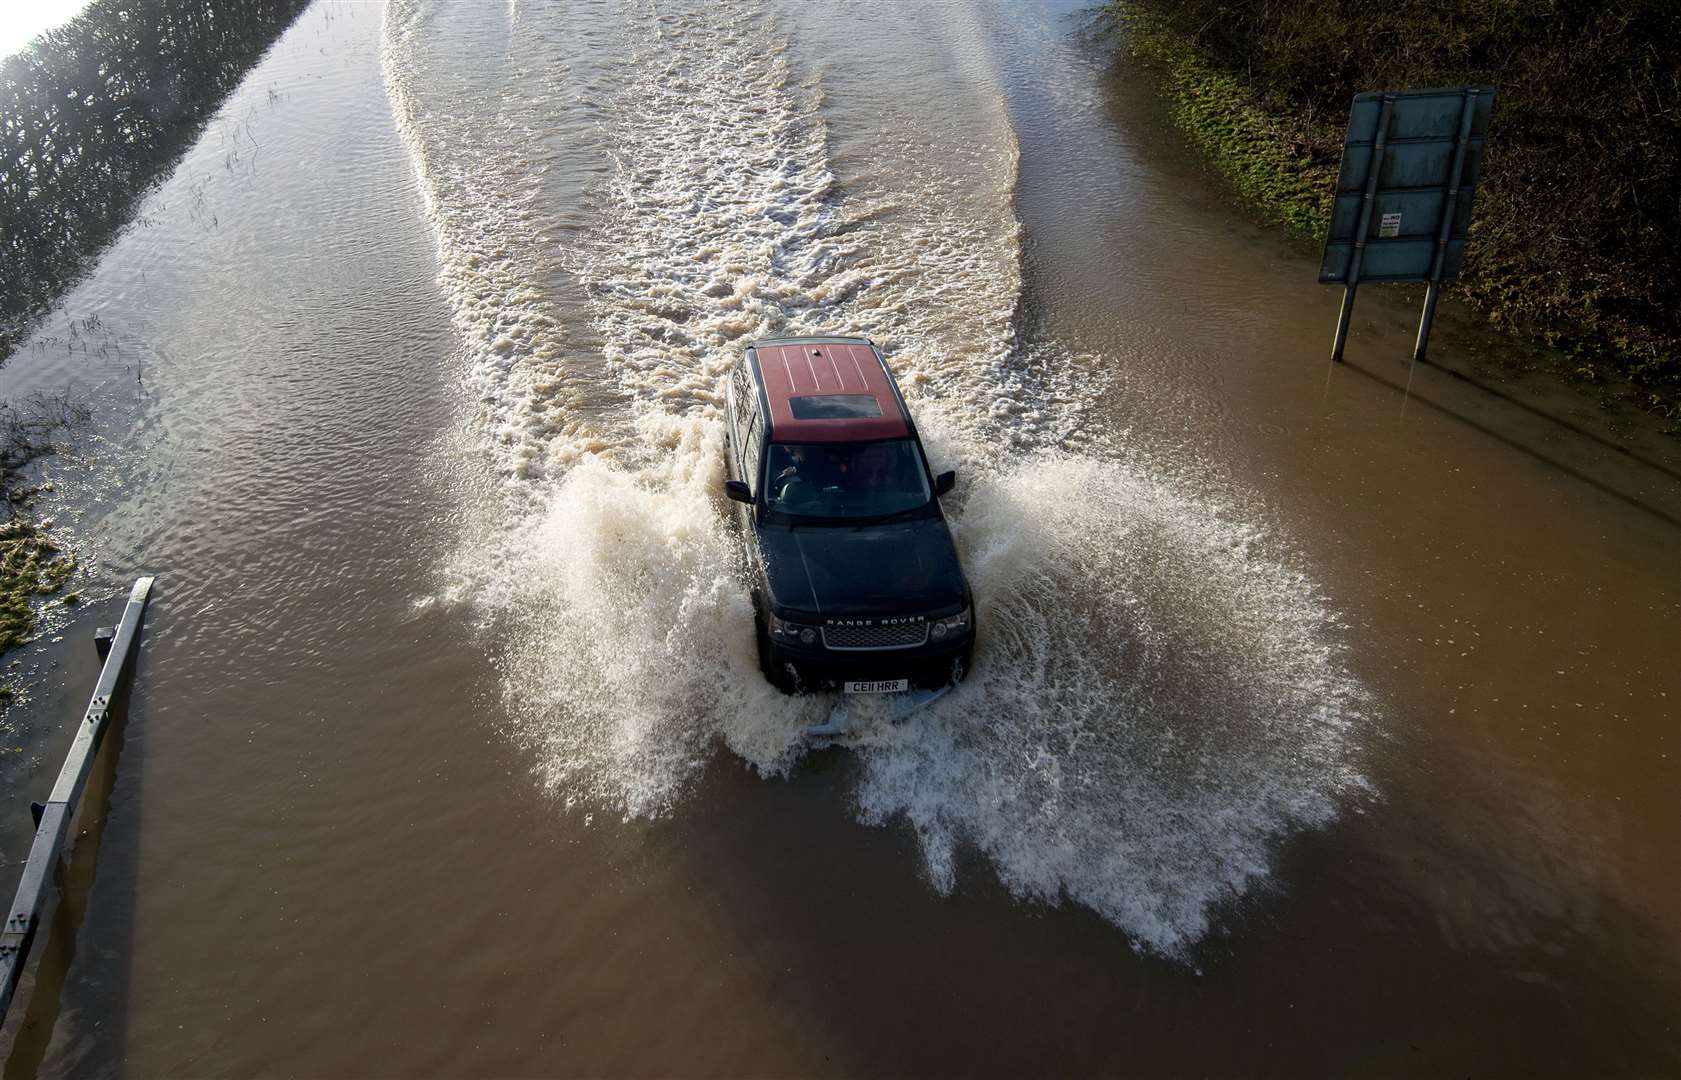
387, 0, 1375, 956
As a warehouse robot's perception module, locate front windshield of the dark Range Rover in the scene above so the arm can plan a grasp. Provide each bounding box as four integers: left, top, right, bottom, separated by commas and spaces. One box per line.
765, 439, 930, 521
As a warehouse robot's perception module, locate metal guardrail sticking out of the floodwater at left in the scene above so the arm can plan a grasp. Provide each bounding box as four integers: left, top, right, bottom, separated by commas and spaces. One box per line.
0, 577, 153, 1023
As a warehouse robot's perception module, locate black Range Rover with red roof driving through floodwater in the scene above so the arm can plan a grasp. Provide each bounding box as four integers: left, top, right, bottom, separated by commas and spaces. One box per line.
725, 336, 975, 693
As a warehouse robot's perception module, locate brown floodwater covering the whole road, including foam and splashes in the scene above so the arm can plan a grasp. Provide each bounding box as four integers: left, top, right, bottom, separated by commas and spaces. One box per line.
0, 0, 1681, 1077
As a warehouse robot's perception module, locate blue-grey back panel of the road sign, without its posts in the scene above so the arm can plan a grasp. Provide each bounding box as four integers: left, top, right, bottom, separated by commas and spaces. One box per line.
1320, 86, 1494, 284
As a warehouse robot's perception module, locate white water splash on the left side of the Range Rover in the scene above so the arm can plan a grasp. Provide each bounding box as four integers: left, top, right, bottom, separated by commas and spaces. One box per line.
493, 419, 825, 816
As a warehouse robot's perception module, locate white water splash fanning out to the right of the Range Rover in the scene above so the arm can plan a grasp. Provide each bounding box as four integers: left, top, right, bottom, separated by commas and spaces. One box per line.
859, 444, 1367, 954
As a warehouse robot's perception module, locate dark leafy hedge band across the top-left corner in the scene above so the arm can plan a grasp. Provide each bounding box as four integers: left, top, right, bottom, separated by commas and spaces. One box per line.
0, 0, 308, 358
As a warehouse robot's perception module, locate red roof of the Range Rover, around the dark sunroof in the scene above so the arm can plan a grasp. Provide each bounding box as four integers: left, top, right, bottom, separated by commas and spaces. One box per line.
755, 336, 911, 442
